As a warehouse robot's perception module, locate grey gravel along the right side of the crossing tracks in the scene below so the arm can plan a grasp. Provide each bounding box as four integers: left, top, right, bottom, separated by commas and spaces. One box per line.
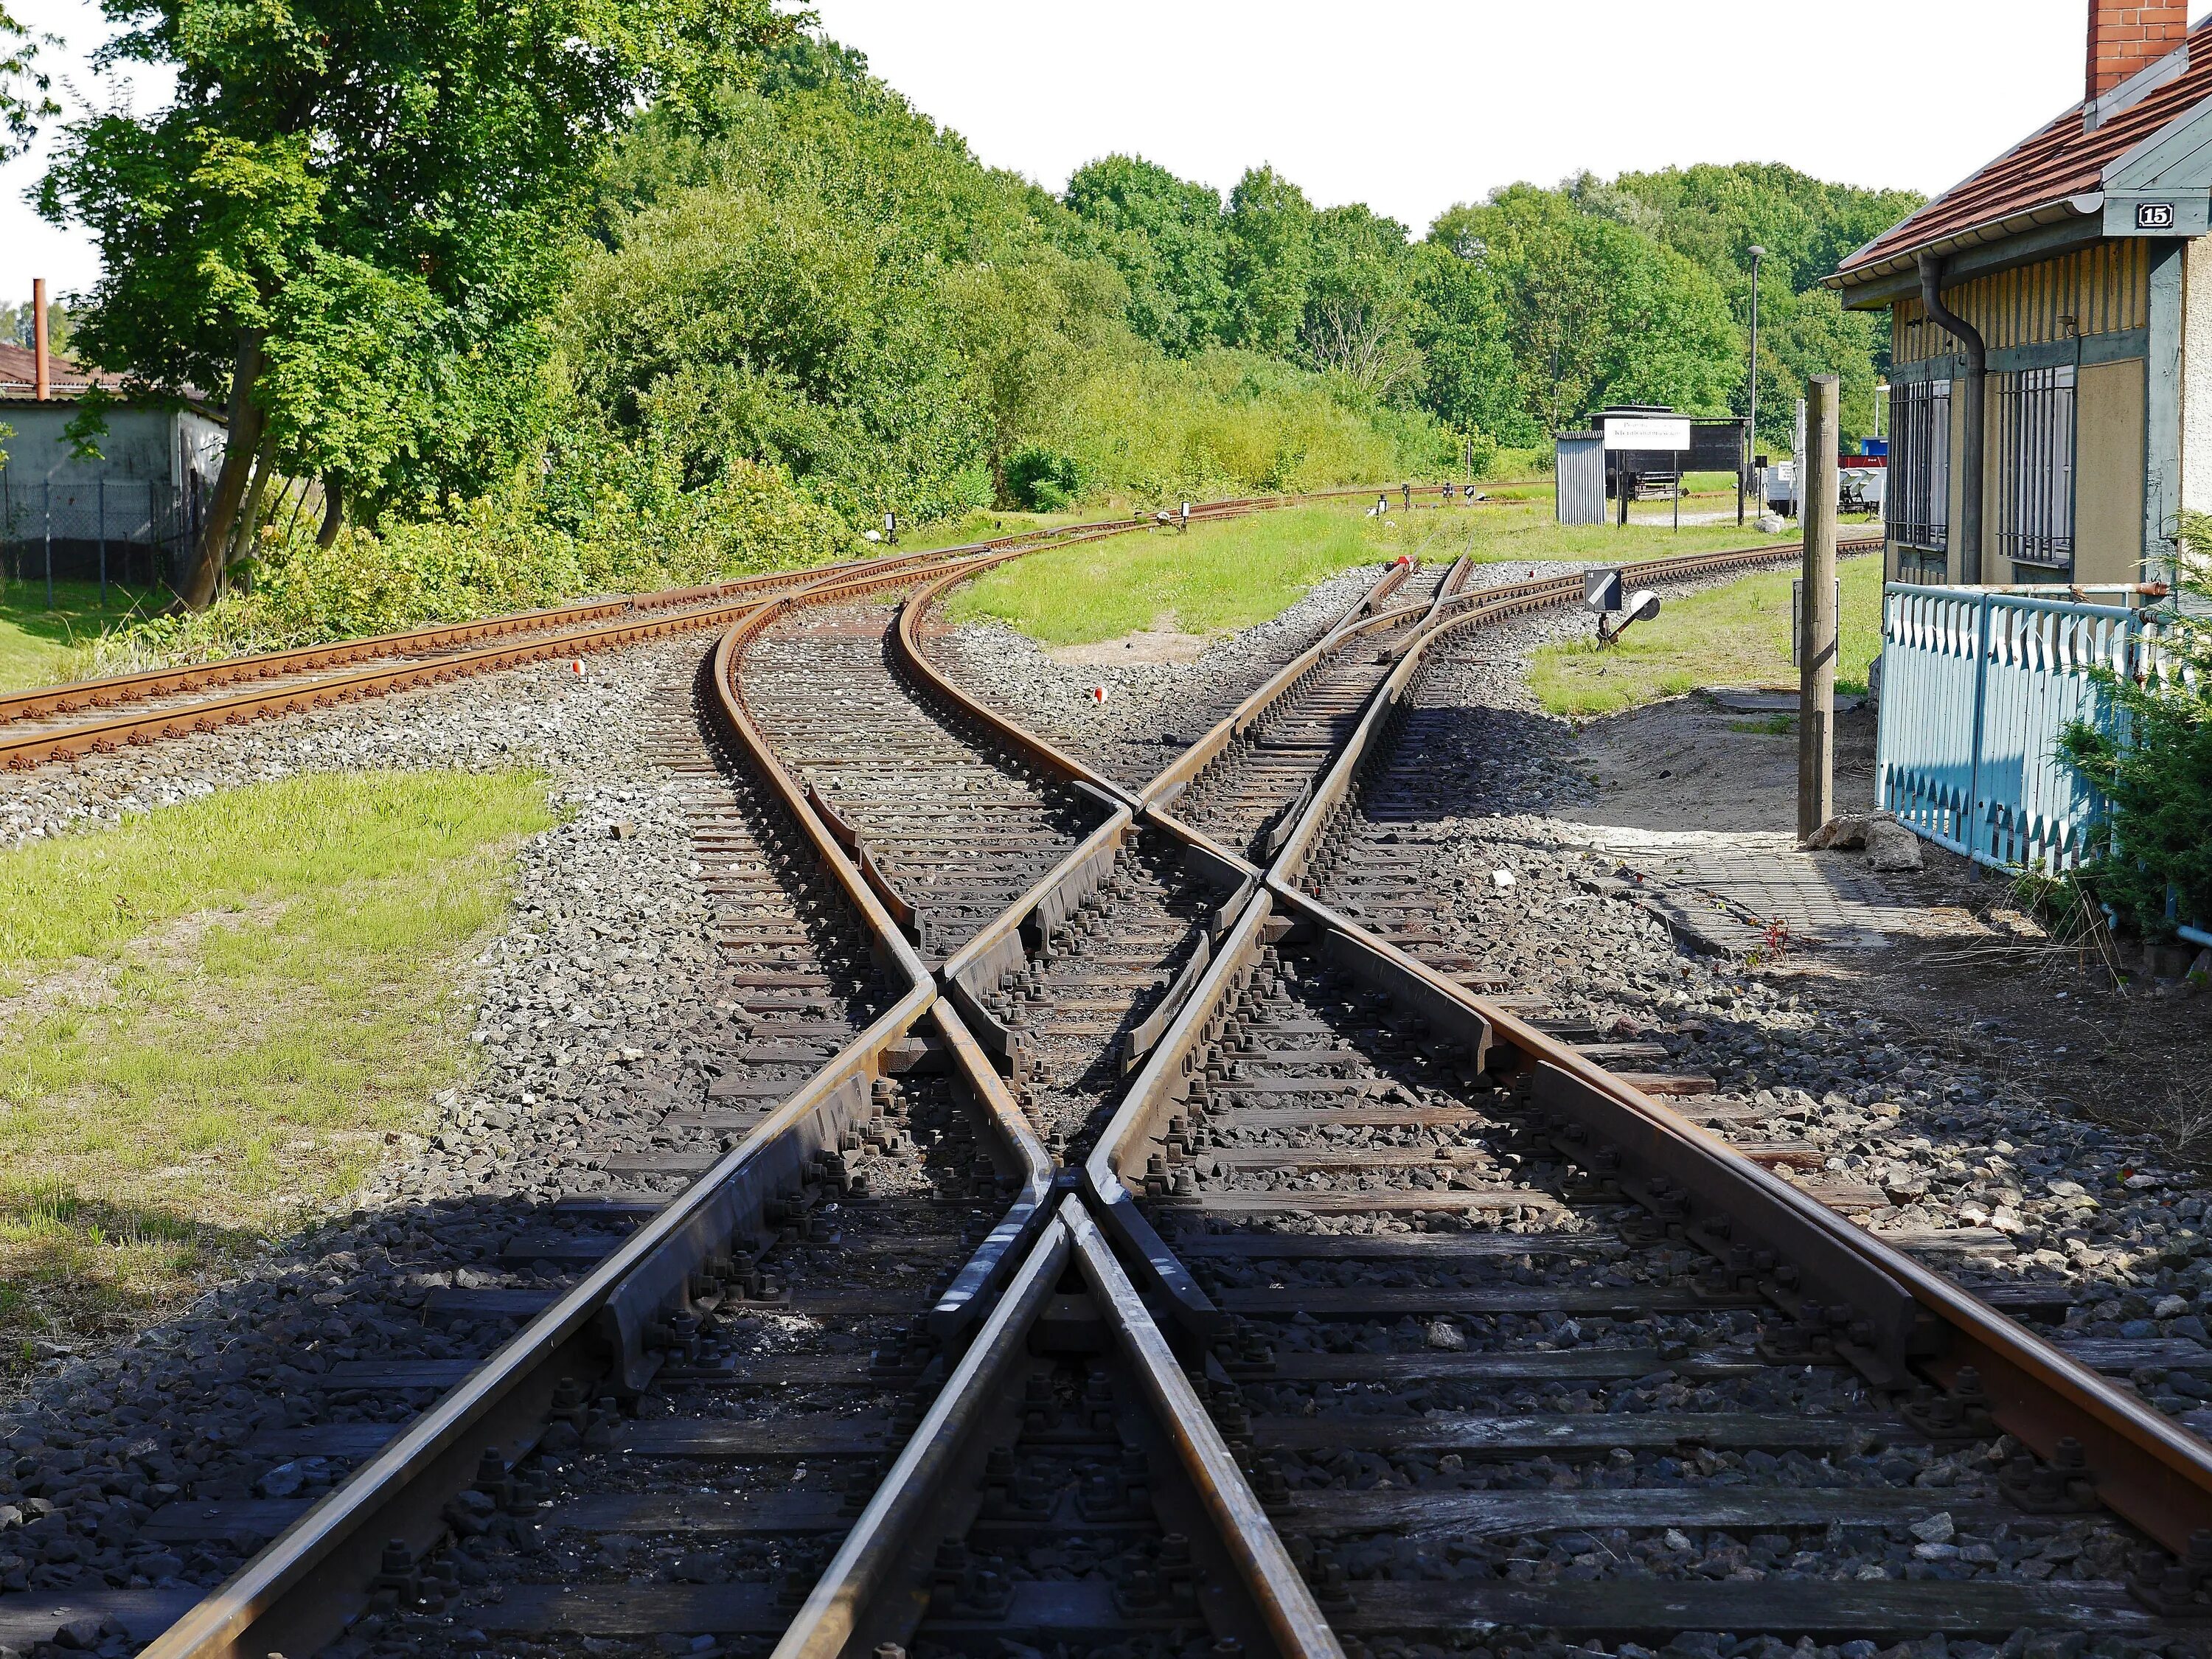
1327, 613, 2212, 1427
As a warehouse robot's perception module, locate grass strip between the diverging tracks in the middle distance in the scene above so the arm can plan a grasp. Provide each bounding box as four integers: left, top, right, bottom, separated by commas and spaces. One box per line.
949, 498, 1792, 646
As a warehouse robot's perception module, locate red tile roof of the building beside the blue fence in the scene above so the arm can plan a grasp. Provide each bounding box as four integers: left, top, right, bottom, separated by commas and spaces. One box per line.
1836, 18, 2212, 281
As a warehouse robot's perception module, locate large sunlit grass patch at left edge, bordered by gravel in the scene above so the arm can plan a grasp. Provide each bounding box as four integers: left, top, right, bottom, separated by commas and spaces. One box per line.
0, 772, 553, 1374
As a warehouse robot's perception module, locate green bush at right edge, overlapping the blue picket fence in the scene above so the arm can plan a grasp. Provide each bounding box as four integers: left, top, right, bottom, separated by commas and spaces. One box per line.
2064, 513, 2212, 938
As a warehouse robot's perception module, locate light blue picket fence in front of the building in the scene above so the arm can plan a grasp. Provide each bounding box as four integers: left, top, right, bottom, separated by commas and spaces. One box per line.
1876, 582, 2170, 872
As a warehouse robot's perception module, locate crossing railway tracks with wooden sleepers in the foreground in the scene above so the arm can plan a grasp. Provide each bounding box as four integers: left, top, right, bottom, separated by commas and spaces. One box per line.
30, 522, 2212, 1659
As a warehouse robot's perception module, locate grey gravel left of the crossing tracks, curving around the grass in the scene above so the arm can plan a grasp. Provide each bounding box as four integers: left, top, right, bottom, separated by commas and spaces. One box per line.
0, 635, 832, 1615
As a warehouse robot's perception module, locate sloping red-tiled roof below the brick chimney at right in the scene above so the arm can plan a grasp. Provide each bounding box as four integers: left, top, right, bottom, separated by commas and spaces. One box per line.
1832, 18, 2212, 288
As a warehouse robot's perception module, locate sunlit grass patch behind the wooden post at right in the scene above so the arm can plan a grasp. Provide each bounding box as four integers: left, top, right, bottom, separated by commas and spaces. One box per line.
1528, 555, 1882, 730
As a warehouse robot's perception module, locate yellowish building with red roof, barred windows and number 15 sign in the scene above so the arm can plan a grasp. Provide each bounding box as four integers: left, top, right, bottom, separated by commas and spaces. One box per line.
1829, 0, 2212, 584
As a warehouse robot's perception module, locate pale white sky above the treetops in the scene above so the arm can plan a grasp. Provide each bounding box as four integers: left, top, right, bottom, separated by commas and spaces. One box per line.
0, 0, 2141, 296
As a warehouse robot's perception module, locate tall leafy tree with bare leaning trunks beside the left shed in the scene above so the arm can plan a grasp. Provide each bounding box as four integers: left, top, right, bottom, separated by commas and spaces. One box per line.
40, 0, 796, 608
